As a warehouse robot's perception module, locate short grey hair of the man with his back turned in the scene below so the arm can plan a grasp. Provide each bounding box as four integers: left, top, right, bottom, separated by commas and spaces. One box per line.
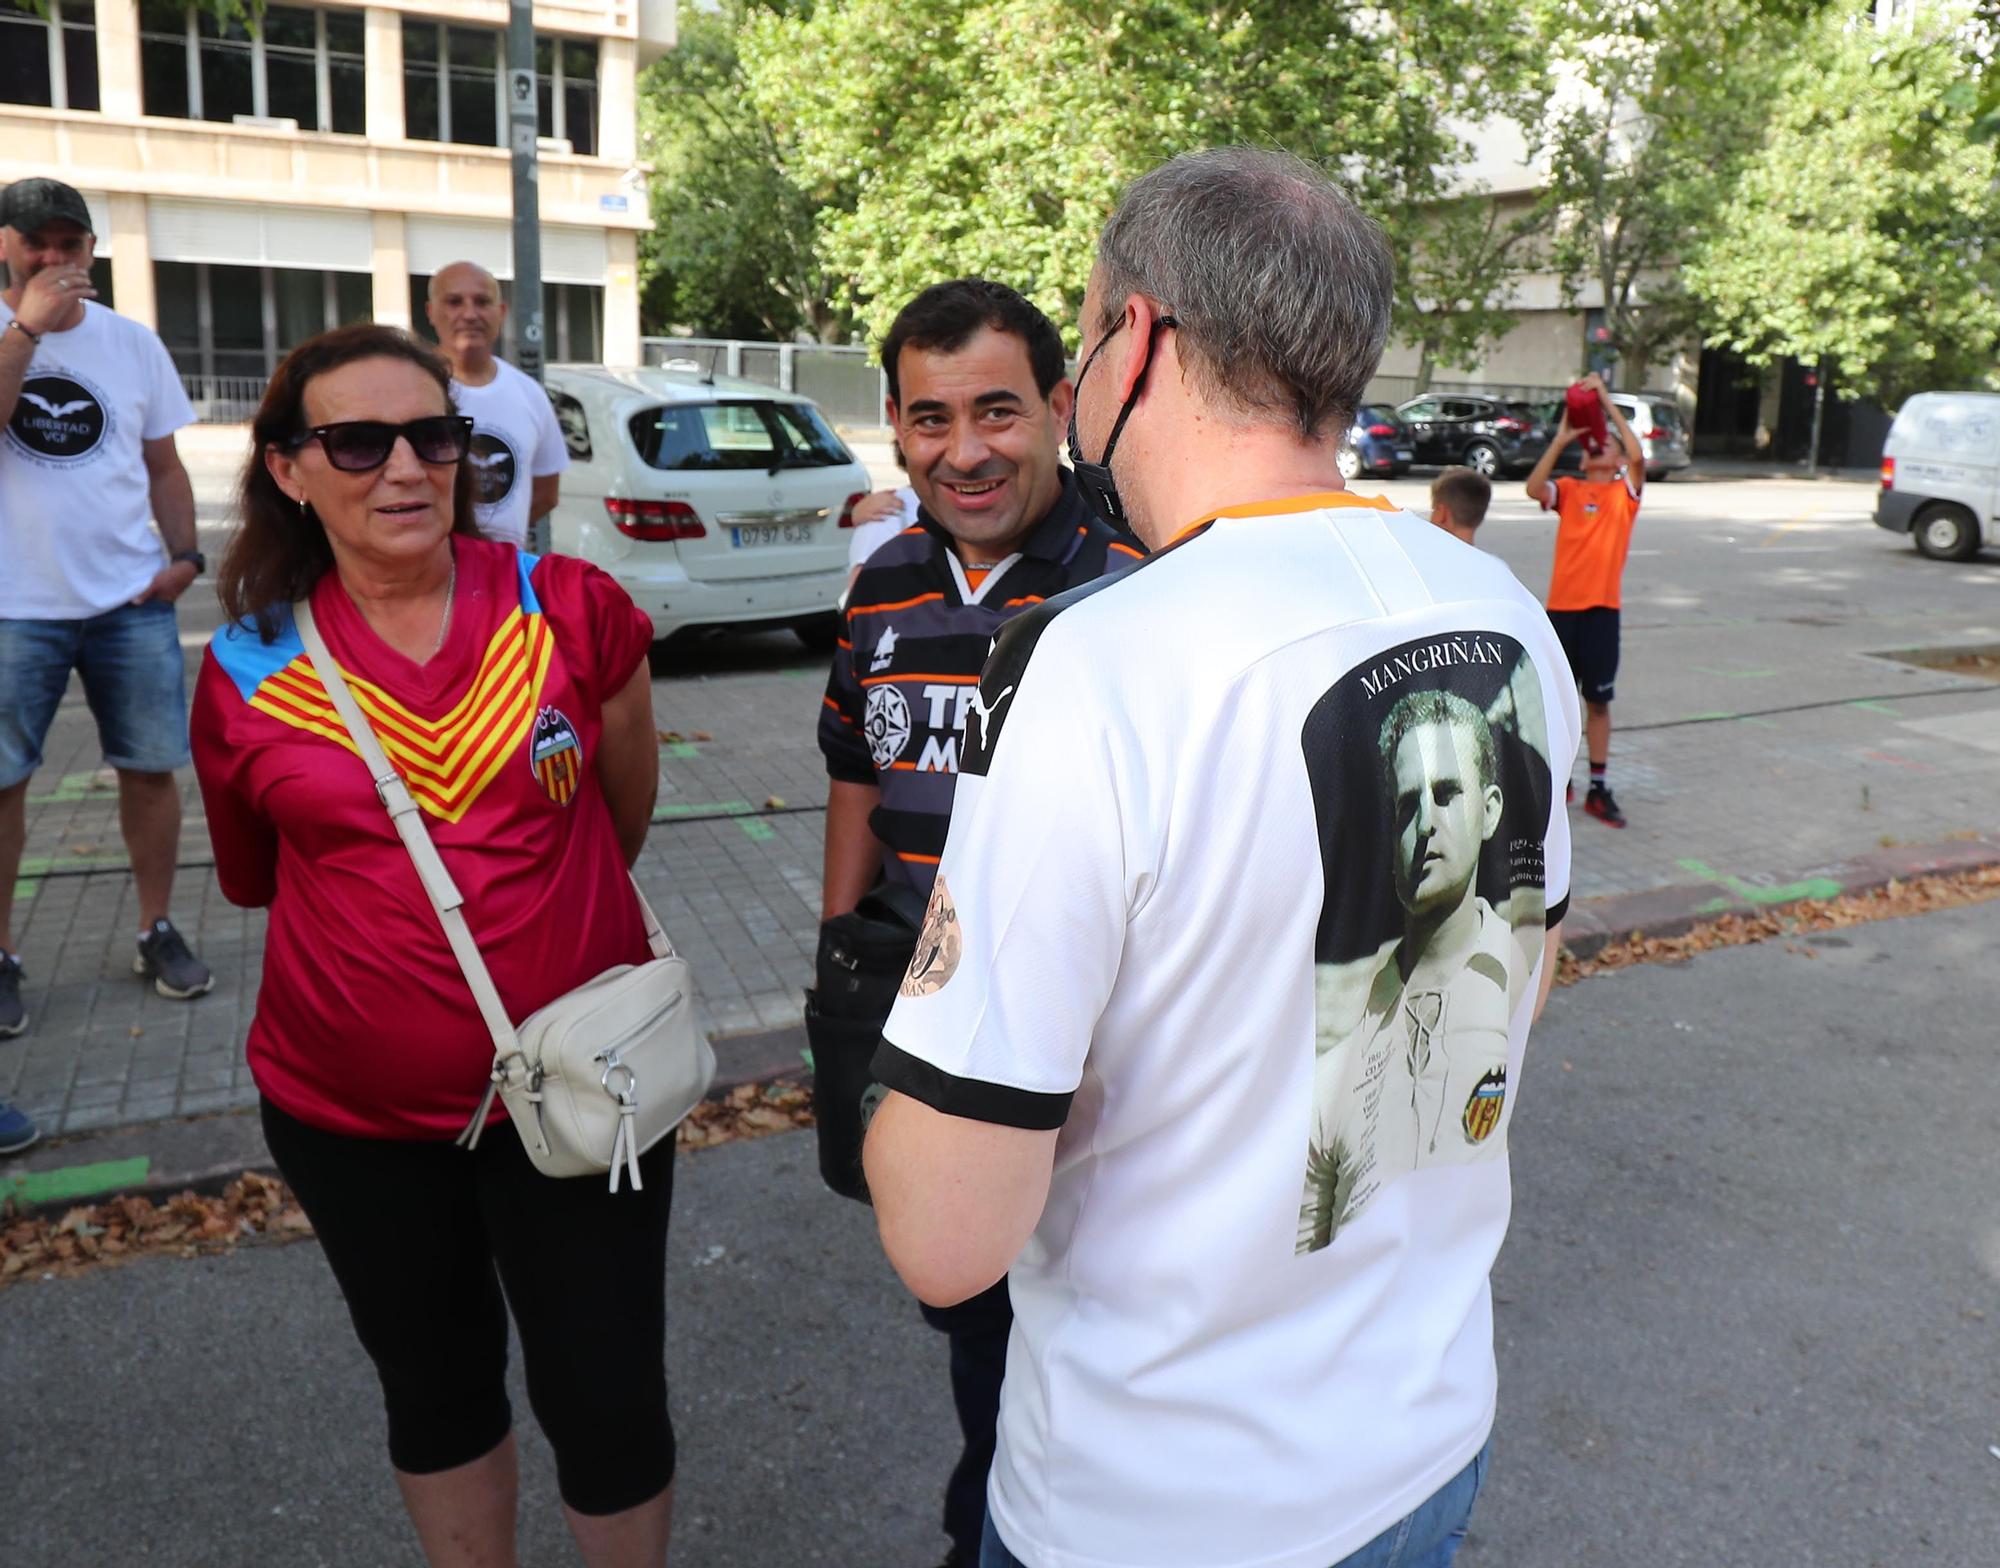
1098, 148, 1396, 440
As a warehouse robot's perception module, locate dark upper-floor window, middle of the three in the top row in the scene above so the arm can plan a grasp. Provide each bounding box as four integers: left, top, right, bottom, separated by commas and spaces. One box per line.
136, 0, 366, 136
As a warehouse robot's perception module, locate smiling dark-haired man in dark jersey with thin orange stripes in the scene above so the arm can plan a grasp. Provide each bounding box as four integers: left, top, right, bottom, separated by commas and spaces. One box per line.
820, 278, 1142, 1564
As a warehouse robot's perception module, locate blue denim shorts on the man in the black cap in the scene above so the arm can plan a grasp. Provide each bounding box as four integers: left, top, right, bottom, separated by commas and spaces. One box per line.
0, 600, 188, 790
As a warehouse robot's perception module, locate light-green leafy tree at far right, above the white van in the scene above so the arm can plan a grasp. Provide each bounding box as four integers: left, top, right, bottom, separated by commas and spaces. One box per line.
1686, 8, 2000, 404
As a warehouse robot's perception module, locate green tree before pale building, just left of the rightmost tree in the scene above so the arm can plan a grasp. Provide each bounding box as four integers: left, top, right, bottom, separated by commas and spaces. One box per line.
1532, 0, 1800, 384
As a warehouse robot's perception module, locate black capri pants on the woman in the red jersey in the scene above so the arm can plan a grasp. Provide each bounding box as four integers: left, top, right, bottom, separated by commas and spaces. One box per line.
262, 1100, 674, 1514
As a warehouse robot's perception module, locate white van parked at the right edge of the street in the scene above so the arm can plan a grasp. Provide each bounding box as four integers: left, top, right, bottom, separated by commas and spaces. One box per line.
1876, 392, 2000, 560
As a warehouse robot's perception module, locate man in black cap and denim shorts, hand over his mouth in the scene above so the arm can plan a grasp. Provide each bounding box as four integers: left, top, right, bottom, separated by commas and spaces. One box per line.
0, 180, 214, 1104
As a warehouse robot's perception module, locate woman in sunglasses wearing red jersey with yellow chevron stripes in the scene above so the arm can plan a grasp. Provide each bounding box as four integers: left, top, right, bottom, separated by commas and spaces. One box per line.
194, 326, 674, 1568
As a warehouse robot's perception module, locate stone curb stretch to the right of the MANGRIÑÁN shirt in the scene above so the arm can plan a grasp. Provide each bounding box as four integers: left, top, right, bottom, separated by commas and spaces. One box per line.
1562, 834, 2000, 958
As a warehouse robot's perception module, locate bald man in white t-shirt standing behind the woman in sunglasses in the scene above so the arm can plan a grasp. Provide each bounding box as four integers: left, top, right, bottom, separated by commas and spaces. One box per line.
424, 262, 570, 546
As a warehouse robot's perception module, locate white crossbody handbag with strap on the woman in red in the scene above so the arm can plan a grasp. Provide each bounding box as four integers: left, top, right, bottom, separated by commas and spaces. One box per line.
292, 600, 716, 1192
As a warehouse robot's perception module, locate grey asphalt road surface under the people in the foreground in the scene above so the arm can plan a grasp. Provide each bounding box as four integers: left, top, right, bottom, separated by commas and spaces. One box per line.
0, 904, 2000, 1568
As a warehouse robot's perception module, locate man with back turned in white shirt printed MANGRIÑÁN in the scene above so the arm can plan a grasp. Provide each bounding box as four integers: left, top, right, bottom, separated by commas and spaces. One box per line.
866, 150, 1580, 1568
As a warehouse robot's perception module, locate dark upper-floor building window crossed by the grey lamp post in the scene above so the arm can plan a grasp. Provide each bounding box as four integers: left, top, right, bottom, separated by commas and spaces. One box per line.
402, 18, 598, 156
